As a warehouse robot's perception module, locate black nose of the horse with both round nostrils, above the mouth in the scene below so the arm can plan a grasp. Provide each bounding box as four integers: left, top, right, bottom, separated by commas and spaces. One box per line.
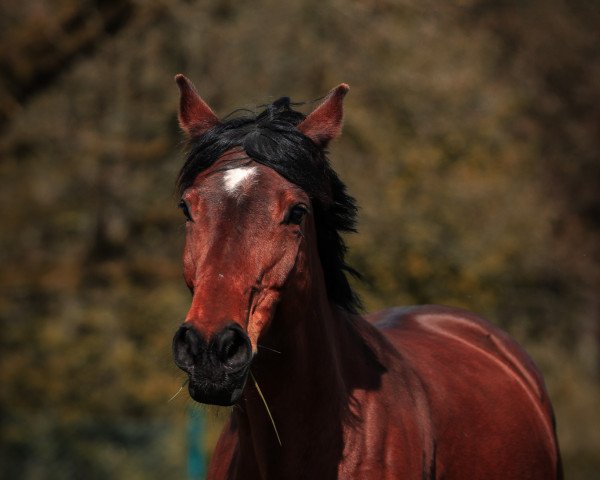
173, 323, 252, 373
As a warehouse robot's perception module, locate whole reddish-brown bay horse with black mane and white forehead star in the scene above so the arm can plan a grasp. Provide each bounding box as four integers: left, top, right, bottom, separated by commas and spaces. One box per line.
173, 75, 562, 480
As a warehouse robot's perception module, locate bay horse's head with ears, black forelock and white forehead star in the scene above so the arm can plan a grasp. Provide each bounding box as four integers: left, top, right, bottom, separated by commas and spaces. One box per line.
173, 75, 355, 405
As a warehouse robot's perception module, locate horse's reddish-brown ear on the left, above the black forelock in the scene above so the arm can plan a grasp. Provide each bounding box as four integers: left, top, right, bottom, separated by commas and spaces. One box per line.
175, 73, 219, 137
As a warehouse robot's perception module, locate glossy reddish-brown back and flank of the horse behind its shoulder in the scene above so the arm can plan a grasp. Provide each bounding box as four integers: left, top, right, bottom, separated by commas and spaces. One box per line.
370, 306, 562, 479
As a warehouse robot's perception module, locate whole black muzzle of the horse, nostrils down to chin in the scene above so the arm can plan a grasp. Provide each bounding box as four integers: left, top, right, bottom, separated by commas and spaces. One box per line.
173, 323, 252, 406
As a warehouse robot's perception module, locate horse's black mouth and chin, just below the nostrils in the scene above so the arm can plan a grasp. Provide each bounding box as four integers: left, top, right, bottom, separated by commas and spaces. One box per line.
188, 368, 249, 407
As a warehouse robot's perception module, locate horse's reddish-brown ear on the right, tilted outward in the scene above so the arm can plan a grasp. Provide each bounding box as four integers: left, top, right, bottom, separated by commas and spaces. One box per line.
298, 83, 350, 147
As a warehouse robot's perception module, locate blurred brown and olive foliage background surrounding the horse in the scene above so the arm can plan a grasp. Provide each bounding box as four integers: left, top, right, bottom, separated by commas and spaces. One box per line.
0, 0, 600, 480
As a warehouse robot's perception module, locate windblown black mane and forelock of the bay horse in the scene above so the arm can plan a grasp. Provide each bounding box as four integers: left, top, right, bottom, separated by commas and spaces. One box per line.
177, 97, 360, 313
